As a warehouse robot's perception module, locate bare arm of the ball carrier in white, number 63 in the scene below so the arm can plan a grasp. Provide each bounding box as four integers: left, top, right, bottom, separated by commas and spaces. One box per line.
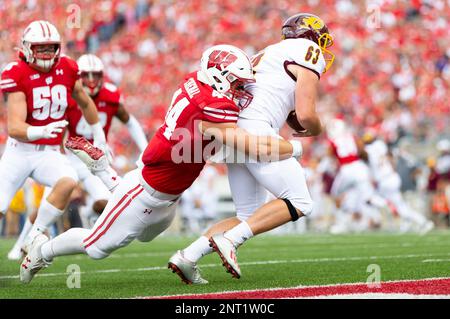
288, 64, 322, 136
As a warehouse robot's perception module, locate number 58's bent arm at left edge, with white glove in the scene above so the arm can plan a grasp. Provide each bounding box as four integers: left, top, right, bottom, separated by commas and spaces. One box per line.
6, 92, 67, 142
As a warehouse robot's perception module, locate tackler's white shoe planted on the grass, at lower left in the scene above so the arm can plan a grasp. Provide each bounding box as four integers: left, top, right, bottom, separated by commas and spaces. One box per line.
20, 234, 51, 284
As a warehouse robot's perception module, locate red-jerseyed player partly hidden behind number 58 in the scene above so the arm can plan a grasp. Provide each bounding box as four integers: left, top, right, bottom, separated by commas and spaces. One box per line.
8, 54, 147, 260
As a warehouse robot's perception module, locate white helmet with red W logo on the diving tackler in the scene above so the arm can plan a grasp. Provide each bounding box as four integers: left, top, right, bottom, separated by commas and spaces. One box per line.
200, 44, 255, 108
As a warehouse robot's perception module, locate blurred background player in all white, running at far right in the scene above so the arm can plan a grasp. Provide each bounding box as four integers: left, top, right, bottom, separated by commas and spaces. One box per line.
363, 132, 434, 234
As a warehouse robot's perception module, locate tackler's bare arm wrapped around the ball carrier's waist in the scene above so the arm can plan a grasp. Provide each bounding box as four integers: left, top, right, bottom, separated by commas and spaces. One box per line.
199, 121, 302, 162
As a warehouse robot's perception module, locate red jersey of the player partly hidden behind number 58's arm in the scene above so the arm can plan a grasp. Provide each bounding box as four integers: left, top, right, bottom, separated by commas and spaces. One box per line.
66, 82, 121, 141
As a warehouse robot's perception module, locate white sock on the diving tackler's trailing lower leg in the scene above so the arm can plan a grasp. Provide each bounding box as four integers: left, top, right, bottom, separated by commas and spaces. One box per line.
41, 228, 90, 261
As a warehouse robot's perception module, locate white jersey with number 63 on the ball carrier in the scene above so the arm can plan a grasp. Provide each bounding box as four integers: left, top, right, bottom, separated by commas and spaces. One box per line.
239, 39, 326, 128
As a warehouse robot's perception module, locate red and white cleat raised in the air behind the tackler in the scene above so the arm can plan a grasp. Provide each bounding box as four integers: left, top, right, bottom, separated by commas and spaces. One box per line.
65, 137, 109, 172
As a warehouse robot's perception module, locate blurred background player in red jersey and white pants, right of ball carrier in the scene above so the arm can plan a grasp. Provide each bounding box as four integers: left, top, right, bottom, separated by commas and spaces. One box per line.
327, 118, 384, 233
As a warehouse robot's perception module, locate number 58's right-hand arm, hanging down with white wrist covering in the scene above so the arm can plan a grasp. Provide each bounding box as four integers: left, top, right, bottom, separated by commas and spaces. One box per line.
72, 80, 107, 152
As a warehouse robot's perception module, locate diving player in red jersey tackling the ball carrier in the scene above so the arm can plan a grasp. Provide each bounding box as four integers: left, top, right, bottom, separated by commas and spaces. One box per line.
20, 45, 301, 283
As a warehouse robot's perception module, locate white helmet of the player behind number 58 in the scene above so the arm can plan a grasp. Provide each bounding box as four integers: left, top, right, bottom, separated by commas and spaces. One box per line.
77, 54, 104, 96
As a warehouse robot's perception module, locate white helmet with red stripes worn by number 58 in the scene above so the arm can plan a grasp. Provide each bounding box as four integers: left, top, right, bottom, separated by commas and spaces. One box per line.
22, 20, 61, 72
